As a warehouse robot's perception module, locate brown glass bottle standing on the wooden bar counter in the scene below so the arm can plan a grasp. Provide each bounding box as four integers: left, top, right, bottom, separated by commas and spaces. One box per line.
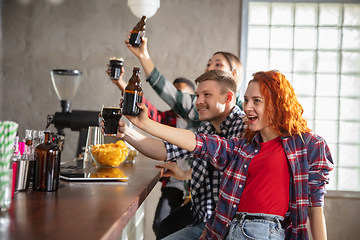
33, 131, 61, 192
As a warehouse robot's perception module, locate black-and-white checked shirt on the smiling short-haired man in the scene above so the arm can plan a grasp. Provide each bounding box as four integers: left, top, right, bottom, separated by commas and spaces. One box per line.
165, 106, 245, 224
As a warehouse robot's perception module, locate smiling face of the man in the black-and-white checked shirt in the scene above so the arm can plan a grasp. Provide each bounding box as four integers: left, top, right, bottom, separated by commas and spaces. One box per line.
195, 80, 228, 121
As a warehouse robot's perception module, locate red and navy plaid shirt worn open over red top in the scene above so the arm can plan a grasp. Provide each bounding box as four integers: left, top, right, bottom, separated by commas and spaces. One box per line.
193, 133, 334, 240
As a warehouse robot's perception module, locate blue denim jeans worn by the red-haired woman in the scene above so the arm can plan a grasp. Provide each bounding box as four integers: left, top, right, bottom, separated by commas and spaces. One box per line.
225, 213, 285, 240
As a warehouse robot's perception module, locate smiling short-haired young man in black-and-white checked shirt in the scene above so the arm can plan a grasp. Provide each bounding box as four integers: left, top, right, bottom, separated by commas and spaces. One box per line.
113, 70, 248, 239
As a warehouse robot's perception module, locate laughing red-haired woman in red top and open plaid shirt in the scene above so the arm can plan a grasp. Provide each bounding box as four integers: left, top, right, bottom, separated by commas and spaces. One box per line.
123, 71, 334, 240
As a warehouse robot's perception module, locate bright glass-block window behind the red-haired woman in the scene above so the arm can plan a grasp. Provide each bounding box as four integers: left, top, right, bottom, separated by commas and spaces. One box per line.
241, 0, 360, 191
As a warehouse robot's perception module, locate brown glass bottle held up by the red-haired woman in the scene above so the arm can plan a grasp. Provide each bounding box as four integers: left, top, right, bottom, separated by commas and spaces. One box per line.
122, 67, 143, 116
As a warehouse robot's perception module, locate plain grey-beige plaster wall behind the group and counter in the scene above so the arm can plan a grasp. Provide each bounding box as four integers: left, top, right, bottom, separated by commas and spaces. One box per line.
1, 0, 240, 161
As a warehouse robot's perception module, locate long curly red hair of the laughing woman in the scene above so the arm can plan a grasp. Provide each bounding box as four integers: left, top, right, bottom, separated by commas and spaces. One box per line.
244, 71, 311, 141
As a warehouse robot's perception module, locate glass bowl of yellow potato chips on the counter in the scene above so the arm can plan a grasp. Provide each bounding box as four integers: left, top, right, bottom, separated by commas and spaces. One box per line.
89, 140, 129, 167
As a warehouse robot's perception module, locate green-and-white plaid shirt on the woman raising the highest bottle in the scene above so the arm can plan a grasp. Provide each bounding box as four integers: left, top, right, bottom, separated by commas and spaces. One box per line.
146, 67, 243, 132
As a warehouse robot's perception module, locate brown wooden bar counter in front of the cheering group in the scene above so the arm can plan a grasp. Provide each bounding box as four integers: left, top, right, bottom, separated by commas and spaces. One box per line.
0, 154, 160, 240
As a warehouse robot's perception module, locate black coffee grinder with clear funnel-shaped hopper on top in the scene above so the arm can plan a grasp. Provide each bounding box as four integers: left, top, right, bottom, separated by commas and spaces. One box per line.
46, 69, 100, 157
